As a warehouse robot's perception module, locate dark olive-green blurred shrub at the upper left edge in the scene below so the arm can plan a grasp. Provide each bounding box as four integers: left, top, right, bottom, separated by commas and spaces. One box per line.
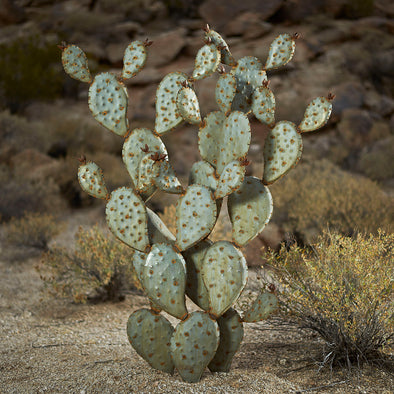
0, 35, 64, 112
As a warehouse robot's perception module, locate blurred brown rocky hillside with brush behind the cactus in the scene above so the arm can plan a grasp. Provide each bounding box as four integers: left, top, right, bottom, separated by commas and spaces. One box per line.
0, 0, 394, 265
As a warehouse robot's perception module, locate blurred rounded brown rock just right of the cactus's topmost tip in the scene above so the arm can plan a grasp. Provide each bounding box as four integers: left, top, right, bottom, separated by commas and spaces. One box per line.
223, 12, 272, 39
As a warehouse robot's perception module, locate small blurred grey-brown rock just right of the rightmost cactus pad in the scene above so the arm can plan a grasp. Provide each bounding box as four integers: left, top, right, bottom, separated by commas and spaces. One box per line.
332, 81, 365, 118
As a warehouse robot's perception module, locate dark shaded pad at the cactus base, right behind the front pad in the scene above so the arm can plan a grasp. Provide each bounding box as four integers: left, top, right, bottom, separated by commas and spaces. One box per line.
208, 308, 244, 372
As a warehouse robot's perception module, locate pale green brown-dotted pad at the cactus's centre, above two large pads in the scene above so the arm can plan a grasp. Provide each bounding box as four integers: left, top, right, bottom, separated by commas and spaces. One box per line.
176, 185, 217, 250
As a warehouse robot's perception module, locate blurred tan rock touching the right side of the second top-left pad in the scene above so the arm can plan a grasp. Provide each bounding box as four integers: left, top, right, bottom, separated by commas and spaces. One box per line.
147, 27, 186, 67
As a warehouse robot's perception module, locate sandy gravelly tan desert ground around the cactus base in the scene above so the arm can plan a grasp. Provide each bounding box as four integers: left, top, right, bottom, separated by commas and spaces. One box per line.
0, 211, 394, 394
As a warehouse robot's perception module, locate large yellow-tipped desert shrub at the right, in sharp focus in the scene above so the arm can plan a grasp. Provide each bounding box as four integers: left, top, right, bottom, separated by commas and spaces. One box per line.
265, 232, 394, 365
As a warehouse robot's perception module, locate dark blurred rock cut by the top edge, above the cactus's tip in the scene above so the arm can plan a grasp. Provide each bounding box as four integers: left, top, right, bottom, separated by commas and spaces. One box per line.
199, 0, 285, 33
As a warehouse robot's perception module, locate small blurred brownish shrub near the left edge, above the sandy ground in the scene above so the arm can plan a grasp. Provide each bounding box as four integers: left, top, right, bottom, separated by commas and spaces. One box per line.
5, 212, 61, 250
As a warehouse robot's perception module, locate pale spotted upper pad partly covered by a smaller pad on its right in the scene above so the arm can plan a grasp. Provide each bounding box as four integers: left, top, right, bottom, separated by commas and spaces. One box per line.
155, 72, 188, 134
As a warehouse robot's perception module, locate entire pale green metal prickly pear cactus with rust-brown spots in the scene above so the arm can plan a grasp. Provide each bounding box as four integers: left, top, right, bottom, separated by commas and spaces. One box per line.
61, 26, 332, 382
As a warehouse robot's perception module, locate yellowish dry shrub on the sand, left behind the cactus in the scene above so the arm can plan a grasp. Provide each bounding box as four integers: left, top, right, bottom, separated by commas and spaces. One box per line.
37, 226, 141, 303
